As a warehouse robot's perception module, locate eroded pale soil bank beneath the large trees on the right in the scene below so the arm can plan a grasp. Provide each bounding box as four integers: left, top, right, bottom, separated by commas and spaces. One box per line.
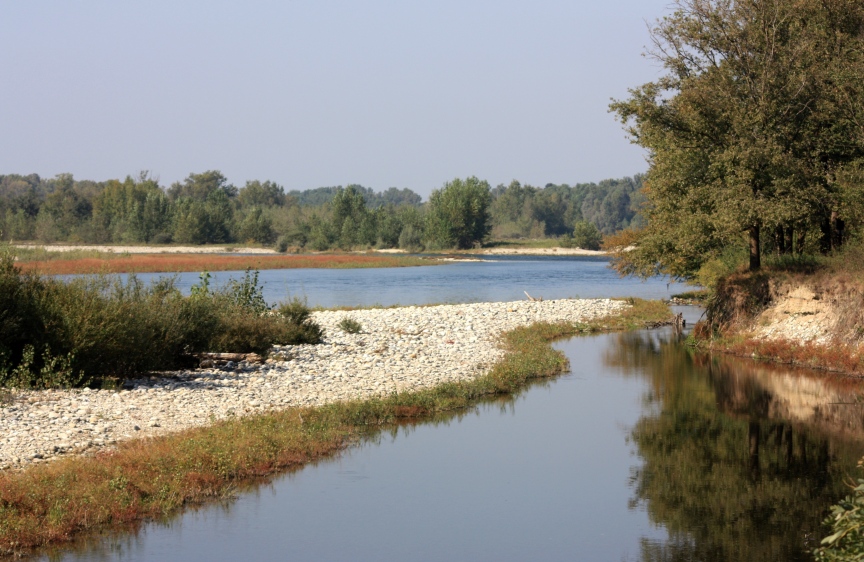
708, 272, 864, 374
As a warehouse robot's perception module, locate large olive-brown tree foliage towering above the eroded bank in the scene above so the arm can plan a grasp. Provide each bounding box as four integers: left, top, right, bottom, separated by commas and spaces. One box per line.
611, 0, 864, 278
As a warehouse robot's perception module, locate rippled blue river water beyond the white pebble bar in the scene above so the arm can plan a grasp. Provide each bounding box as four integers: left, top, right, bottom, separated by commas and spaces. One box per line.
125, 256, 688, 307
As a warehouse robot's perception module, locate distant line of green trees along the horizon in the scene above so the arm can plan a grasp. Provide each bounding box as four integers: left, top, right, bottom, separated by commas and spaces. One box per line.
0, 170, 643, 251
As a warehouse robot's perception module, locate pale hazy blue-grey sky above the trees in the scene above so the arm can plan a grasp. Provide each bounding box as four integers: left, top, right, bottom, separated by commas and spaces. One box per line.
0, 0, 669, 197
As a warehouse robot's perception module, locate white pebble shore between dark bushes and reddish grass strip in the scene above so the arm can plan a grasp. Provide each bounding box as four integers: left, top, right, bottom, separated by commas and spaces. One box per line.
0, 299, 627, 469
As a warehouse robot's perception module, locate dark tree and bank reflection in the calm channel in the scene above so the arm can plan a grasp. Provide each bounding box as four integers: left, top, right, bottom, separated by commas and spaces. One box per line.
604, 333, 864, 561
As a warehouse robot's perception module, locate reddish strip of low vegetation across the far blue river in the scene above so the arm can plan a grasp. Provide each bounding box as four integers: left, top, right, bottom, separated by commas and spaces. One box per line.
18, 254, 435, 275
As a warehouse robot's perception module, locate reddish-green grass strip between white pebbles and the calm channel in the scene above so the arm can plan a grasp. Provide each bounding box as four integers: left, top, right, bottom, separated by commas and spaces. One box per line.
0, 300, 669, 554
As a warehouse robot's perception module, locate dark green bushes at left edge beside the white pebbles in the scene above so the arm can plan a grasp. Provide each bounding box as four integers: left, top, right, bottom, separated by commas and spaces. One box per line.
0, 247, 322, 388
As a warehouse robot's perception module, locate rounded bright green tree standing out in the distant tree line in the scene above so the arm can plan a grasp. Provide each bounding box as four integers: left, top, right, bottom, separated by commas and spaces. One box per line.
426, 176, 492, 249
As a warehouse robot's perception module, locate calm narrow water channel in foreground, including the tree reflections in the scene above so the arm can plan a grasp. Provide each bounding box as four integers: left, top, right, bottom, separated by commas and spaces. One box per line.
42, 310, 864, 562
